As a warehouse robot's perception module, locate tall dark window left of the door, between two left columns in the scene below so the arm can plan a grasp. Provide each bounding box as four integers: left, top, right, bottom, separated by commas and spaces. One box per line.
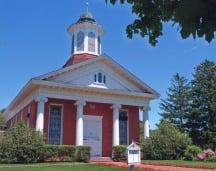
48, 105, 62, 144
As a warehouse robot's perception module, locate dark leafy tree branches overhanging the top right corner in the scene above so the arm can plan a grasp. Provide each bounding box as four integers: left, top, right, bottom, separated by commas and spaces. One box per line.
106, 0, 216, 46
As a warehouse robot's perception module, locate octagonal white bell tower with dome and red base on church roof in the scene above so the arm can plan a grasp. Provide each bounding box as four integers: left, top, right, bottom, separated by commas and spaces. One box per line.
64, 6, 104, 67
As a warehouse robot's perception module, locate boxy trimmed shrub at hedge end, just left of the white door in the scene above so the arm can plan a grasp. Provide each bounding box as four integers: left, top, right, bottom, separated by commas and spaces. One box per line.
76, 146, 91, 162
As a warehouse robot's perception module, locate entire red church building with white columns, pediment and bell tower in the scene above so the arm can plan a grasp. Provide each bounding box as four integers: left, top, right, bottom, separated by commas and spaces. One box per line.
4, 9, 159, 156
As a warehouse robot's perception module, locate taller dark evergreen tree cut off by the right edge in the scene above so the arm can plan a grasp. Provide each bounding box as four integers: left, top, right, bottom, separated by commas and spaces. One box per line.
186, 60, 216, 149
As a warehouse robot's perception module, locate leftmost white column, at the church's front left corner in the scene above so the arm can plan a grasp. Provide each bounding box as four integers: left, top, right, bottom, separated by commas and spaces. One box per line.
35, 97, 48, 134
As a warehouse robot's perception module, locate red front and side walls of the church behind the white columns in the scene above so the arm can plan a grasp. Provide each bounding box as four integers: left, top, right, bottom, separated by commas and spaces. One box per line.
7, 99, 139, 156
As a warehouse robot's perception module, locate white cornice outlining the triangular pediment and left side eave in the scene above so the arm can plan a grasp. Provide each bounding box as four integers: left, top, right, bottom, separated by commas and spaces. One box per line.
4, 54, 160, 120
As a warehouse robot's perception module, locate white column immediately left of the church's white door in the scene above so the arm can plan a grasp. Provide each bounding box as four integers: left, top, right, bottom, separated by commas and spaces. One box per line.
75, 101, 86, 146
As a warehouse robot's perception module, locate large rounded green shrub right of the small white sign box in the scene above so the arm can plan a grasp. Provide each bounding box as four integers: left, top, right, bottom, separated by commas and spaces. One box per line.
141, 123, 191, 160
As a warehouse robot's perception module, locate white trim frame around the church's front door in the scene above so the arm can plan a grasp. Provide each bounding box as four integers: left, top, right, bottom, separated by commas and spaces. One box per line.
83, 114, 103, 156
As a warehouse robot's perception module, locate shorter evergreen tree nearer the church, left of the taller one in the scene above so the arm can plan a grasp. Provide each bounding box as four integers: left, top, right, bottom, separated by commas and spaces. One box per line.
160, 73, 190, 132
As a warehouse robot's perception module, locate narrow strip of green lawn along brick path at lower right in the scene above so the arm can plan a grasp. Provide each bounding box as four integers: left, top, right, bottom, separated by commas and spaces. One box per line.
142, 160, 216, 169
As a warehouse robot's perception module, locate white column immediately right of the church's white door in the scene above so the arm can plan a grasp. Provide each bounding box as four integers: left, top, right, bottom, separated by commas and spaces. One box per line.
112, 104, 121, 146
